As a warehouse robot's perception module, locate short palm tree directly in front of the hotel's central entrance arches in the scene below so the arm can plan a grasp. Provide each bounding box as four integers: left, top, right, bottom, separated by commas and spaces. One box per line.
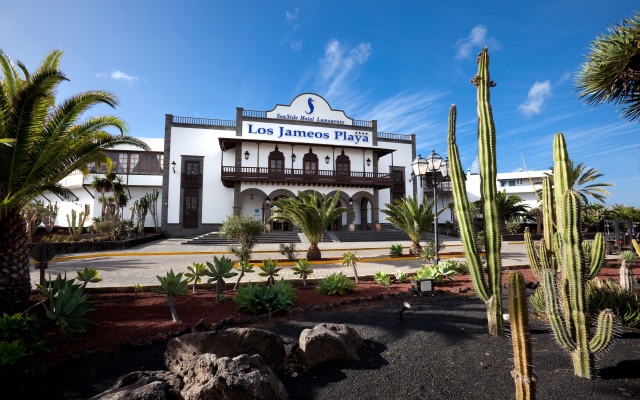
270, 190, 347, 261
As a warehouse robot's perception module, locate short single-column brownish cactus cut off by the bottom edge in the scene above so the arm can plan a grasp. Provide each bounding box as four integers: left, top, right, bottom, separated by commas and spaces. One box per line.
509, 272, 536, 400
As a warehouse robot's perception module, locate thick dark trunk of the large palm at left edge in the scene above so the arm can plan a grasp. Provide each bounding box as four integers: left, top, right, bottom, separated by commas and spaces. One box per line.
0, 214, 31, 313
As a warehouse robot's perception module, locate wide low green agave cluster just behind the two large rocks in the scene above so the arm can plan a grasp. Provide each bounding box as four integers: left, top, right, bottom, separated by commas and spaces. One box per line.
233, 279, 296, 314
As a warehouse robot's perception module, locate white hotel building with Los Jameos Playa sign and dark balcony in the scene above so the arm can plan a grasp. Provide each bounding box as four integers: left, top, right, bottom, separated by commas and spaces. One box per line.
162, 93, 417, 236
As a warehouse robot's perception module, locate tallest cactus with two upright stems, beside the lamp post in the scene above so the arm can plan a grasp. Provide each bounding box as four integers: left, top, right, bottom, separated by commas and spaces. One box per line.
449, 47, 504, 336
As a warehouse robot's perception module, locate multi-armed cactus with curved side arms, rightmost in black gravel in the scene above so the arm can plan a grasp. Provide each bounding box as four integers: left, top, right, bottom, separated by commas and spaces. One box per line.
525, 133, 613, 378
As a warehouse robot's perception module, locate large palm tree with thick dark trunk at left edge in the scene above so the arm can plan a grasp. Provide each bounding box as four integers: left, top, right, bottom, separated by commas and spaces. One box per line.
0, 50, 148, 312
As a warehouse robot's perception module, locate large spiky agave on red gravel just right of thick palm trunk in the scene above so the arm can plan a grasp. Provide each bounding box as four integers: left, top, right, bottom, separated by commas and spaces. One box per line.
37, 274, 95, 336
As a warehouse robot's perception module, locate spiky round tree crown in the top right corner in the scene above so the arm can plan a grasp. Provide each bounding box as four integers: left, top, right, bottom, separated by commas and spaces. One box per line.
576, 13, 640, 121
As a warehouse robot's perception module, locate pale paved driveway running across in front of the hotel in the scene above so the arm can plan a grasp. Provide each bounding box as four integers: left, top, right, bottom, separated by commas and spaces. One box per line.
31, 239, 540, 290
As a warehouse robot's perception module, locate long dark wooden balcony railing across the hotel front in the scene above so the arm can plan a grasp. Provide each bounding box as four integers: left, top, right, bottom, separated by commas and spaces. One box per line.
221, 166, 392, 189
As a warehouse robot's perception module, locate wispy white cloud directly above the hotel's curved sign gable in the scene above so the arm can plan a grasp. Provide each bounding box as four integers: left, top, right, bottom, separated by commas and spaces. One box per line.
320, 39, 371, 97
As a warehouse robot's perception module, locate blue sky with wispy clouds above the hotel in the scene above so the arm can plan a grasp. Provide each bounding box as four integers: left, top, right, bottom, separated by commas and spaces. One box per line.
0, 0, 640, 207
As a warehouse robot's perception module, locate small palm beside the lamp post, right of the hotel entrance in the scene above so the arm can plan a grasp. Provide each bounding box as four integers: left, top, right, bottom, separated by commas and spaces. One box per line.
382, 196, 442, 254
